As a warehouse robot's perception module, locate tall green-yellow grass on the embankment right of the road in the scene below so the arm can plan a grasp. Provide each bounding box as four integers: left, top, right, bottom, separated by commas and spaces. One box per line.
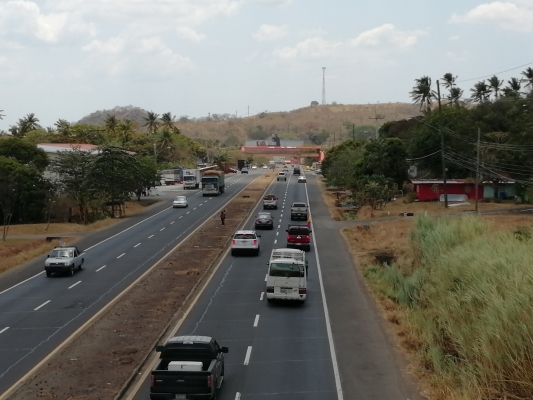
362, 216, 533, 400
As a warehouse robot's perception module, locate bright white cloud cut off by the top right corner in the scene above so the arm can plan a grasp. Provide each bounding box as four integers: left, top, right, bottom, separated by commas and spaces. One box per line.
450, 1, 533, 32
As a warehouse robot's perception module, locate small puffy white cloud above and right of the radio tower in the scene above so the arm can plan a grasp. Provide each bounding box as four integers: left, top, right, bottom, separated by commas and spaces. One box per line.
352, 24, 425, 48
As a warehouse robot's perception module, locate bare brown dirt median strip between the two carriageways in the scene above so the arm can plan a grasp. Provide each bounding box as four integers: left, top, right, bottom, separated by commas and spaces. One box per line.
9, 174, 273, 400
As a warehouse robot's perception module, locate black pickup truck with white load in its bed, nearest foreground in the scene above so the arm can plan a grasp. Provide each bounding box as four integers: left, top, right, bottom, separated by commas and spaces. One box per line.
150, 336, 228, 400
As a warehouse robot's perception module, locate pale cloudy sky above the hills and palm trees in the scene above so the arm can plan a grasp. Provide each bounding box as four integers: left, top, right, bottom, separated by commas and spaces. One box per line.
0, 0, 533, 130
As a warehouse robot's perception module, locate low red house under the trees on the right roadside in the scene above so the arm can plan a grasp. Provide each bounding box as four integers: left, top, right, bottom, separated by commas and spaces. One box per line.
411, 179, 484, 201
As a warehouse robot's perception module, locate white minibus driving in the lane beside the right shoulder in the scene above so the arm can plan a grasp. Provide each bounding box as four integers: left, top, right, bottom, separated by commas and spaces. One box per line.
266, 249, 308, 303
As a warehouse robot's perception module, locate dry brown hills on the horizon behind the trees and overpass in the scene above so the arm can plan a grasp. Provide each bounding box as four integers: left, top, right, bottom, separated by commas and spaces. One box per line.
78, 103, 420, 145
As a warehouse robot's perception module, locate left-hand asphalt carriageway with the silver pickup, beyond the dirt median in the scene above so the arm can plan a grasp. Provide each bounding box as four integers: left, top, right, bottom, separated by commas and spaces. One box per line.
0, 171, 262, 393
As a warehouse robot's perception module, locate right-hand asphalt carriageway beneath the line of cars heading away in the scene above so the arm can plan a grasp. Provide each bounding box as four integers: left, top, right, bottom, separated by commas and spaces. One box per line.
129, 174, 342, 400
